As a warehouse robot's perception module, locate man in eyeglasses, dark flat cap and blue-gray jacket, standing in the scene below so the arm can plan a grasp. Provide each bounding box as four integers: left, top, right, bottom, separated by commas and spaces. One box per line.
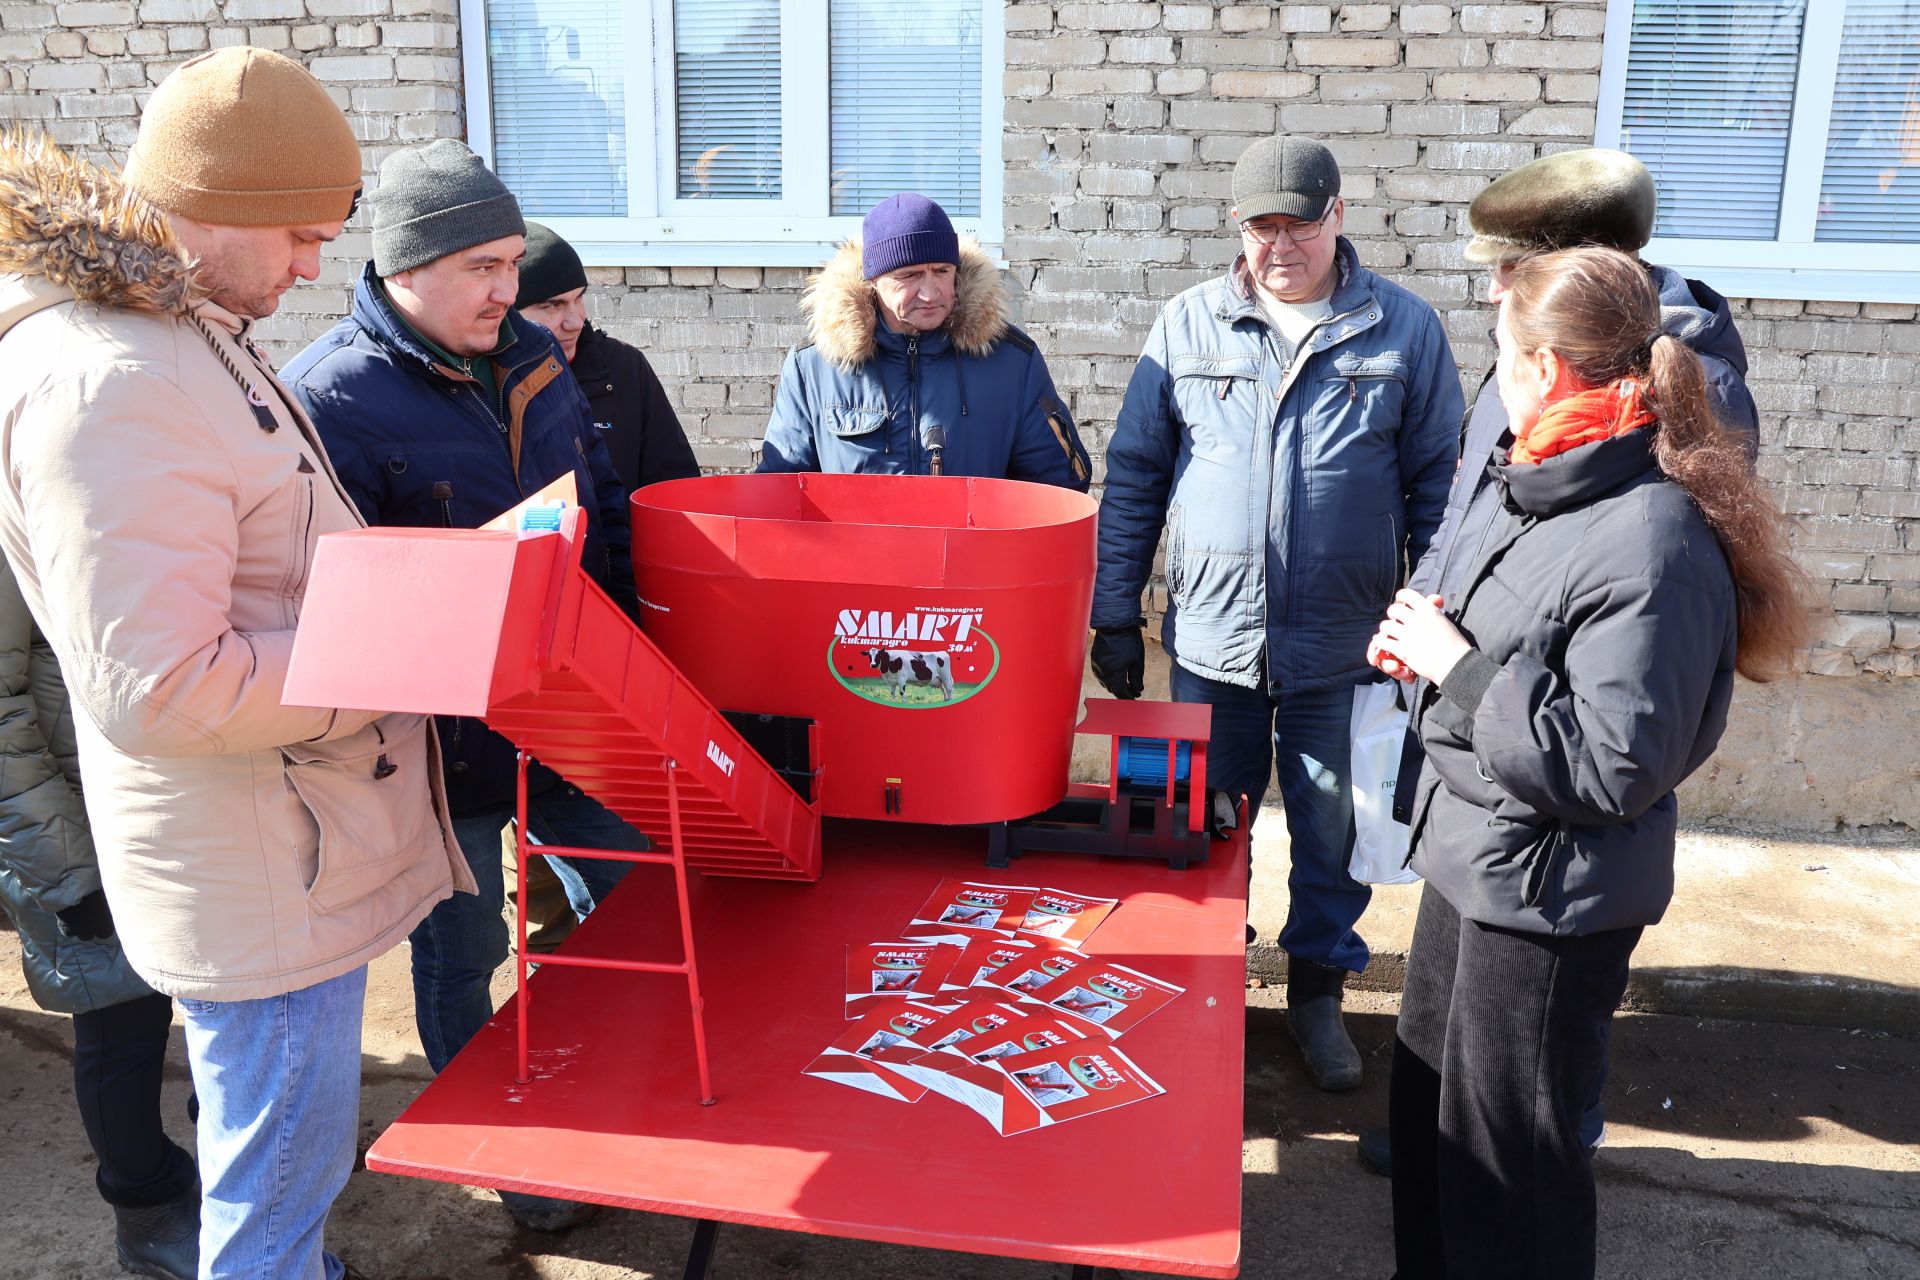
1092, 138, 1463, 1090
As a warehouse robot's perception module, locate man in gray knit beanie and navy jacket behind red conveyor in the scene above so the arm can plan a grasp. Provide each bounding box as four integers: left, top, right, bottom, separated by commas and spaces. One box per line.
286, 138, 647, 1230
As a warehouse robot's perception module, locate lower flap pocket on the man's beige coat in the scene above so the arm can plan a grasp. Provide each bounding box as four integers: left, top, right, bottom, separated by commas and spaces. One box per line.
280, 714, 436, 913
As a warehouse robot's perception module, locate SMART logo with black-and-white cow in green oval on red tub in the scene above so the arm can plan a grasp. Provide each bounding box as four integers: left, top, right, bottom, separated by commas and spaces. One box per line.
828, 608, 1000, 710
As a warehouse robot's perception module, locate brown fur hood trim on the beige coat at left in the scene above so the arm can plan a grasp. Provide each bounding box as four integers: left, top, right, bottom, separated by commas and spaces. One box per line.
0, 129, 200, 315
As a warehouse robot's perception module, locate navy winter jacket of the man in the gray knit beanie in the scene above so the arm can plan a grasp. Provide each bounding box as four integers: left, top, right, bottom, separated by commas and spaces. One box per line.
282, 263, 639, 814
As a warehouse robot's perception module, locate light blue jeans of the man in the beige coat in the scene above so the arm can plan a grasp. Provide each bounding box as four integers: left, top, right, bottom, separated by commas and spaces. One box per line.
179, 967, 367, 1280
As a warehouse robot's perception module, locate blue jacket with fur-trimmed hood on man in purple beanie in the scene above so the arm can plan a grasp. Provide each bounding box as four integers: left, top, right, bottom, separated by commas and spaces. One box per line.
760, 242, 1091, 493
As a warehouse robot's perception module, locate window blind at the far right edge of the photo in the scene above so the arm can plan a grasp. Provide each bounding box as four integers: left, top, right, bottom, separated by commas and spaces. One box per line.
1814, 0, 1920, 244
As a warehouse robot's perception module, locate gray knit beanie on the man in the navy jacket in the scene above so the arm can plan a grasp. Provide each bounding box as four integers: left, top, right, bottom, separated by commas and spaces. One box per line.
371, 138, 526, 276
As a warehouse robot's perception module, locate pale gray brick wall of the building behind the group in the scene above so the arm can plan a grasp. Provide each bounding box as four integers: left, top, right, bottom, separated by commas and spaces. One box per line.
0, 0, 1920, 821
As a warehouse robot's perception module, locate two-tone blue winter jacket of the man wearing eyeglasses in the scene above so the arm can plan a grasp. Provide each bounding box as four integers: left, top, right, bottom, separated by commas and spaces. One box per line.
1092, 238, 1463, 693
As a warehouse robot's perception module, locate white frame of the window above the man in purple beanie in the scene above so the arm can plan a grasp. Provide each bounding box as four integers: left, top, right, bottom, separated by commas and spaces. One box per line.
461, 0, 1006, 267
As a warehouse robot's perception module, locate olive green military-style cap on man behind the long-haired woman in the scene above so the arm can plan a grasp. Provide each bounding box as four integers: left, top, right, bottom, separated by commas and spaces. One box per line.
1467, 146, 1659, 263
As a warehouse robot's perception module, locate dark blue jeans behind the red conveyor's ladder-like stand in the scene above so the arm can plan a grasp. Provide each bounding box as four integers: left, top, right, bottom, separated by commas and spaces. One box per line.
411, 785, 647, 1071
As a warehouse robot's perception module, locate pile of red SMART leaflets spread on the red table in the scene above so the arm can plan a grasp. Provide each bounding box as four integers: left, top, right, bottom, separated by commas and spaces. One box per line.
806, 881, 1183, 1136
